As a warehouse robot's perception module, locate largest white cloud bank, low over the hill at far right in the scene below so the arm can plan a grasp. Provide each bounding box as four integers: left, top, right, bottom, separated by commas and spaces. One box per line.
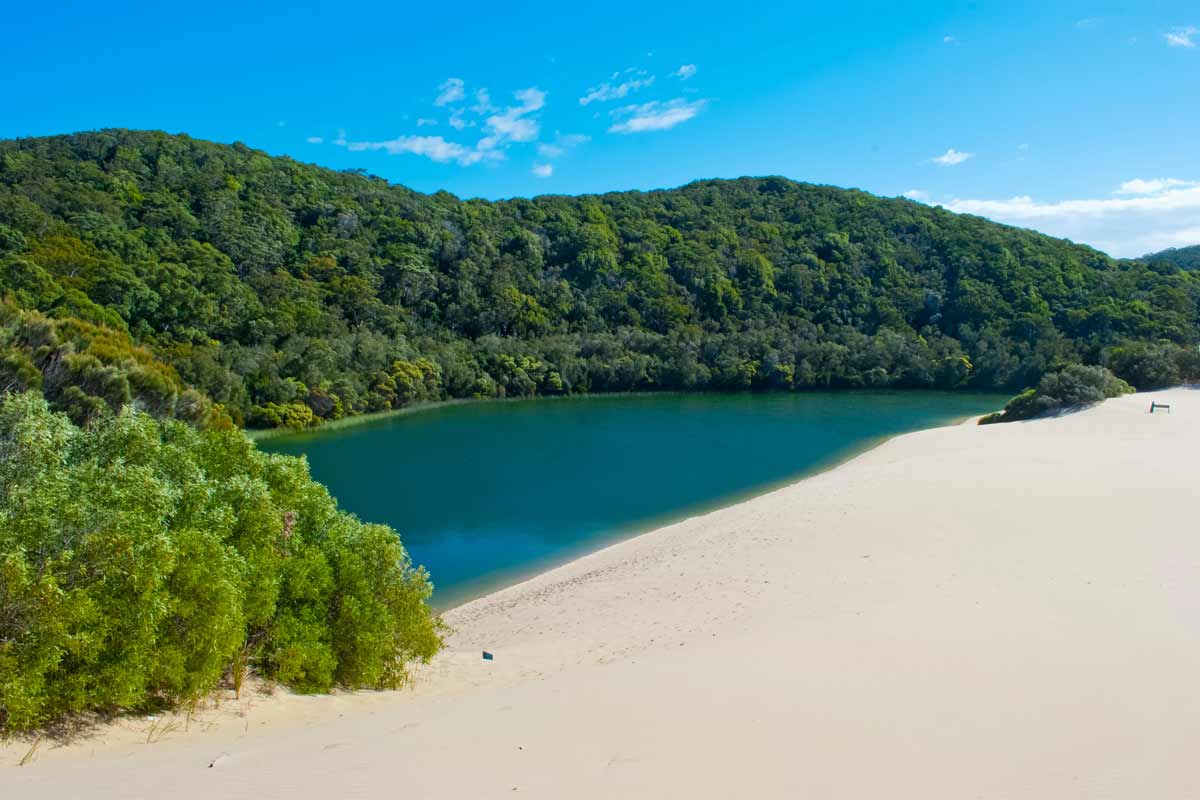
944, 179, 1200, 258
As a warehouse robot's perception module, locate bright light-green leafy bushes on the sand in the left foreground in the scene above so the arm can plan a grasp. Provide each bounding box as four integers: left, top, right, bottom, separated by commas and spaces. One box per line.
0, 392, 440, 729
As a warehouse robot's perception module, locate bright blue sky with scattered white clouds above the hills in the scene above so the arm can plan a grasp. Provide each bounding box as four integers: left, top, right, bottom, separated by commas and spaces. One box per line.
7, 0, 1200, 255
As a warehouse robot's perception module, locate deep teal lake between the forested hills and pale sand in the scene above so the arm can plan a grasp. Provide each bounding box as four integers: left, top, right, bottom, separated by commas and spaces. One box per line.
260, 391, 1003, 607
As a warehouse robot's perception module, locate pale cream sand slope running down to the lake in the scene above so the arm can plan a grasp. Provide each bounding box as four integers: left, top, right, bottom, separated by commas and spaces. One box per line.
0, 389, 1200, 800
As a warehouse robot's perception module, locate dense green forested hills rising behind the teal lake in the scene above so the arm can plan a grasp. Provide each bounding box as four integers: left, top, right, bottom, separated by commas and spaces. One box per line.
0, 131, 1200, 426
